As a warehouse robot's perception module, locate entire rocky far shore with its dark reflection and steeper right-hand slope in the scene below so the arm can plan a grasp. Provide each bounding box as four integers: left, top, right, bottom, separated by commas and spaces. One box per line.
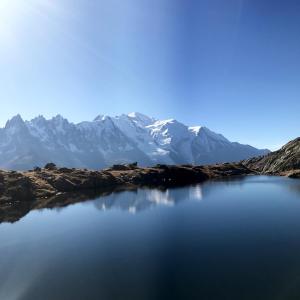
0, 138, 300, 222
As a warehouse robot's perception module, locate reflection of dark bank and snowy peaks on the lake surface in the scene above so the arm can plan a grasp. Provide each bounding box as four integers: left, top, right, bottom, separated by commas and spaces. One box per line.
0, 185, 202, 223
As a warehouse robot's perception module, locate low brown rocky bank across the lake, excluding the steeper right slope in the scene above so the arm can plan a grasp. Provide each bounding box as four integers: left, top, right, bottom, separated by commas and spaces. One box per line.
0, 163, 254, 203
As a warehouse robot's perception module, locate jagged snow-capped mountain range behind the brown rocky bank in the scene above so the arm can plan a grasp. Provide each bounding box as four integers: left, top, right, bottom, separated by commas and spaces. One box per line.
0, 113, 268, 170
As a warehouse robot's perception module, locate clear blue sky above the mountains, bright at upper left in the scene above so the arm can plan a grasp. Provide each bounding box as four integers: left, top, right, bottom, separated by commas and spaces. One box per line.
0, 0, 300, 149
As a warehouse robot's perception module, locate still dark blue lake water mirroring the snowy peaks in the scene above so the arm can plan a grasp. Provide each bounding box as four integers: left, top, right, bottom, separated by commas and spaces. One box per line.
0, 177, 300, 300
